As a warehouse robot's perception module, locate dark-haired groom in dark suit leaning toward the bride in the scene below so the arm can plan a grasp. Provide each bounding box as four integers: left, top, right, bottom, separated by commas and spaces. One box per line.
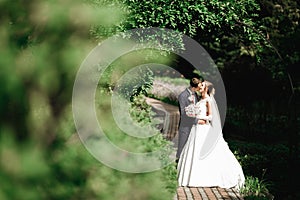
176, 76, 204, 163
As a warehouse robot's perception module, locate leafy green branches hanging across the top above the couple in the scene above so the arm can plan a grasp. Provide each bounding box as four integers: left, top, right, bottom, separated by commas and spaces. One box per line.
88, 0, 266, 60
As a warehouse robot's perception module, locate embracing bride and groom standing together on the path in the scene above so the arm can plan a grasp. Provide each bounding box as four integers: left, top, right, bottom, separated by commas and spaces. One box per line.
176, 76, 245, 189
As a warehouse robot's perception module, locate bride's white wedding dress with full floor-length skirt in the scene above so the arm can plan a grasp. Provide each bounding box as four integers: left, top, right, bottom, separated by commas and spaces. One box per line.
177, 97, 245, 189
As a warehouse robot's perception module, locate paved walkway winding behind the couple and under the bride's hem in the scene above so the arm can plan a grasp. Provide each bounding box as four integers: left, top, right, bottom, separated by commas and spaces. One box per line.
146, 98, 243, 200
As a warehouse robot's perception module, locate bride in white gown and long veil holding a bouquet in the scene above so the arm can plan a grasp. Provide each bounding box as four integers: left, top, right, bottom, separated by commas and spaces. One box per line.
177, 81, 245, 189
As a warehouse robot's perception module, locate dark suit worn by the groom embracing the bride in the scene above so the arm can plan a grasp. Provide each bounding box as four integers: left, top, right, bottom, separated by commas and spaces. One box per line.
176, 88, 198, 158
